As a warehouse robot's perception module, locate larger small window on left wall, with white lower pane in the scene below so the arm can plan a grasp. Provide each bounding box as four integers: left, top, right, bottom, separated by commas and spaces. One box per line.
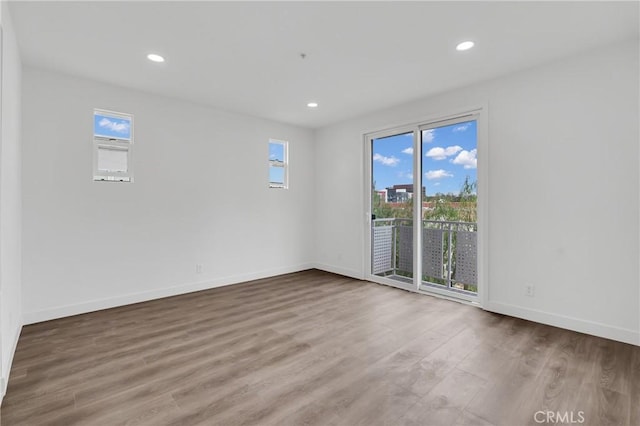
93, 109, 133, 182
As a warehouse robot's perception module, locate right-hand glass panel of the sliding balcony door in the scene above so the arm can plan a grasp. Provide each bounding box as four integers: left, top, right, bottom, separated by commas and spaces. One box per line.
420, 118, 478, 295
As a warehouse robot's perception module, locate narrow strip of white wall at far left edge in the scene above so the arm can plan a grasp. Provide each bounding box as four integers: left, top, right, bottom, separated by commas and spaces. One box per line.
0, 2, 22, 395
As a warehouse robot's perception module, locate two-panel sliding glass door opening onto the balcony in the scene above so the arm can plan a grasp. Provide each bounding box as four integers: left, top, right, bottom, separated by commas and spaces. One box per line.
365, 113, 478, 301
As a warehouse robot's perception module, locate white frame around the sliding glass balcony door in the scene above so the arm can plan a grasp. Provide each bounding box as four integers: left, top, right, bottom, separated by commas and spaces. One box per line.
363, 104, 489, 306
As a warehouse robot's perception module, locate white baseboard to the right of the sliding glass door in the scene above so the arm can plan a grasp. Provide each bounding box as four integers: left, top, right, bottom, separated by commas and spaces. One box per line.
483, 302, 640, 346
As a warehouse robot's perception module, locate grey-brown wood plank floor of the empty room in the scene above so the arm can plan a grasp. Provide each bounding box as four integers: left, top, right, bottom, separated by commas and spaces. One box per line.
0, 270, 640, 426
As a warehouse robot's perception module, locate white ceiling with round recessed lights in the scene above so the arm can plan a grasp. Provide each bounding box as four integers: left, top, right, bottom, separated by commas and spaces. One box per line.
11, 1, 639, 128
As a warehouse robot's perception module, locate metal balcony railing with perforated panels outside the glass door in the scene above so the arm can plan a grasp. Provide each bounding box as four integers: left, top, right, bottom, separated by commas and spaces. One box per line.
371, 218, 478, 293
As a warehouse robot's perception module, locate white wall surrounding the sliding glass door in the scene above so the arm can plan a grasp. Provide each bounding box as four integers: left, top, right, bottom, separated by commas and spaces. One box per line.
316, 41, 640, 344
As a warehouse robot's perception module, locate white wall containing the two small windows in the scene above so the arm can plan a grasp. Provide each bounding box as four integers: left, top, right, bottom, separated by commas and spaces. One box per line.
22, 67, 314, 323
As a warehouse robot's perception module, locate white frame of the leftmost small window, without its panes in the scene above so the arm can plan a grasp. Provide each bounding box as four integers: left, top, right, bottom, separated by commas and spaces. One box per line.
93, 108, 134, 183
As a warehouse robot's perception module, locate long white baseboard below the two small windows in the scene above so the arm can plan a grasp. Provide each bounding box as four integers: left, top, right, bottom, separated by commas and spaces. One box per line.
23, 263, 315, 324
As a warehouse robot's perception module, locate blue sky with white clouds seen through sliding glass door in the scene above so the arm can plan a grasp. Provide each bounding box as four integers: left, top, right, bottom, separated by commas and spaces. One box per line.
372, 121, 477, 195
